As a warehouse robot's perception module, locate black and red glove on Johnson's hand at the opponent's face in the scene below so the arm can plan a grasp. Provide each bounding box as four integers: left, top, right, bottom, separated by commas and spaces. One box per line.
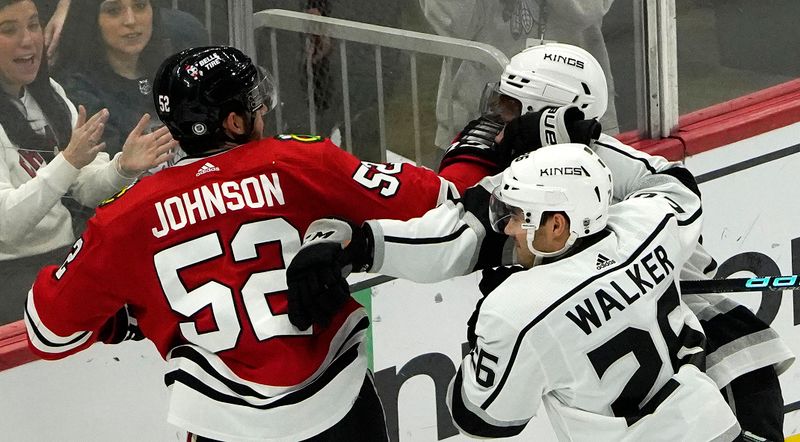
439, 117, 506, 172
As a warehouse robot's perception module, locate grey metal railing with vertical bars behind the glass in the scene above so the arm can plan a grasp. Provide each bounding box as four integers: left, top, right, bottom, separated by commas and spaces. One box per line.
253, 9, 508, 164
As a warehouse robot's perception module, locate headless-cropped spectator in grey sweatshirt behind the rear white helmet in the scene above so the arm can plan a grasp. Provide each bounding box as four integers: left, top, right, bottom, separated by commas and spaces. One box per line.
419, 0, 619, 147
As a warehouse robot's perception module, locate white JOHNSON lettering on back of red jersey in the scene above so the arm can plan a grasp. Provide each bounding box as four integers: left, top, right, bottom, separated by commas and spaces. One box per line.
152, 173, 286, 238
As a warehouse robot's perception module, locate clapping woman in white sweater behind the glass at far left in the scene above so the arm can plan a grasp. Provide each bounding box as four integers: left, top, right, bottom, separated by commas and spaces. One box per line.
0, 0, 175, 324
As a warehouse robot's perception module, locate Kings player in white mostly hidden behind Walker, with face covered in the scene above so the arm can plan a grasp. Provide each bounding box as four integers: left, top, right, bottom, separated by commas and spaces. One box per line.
481, 43, 794, 440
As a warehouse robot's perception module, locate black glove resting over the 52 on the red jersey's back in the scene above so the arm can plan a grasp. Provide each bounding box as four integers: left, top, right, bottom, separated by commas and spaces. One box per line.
286, 218, 372, 330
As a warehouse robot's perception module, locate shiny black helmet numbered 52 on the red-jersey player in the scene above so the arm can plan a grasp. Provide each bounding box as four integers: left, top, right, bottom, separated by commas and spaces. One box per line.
153, 46, 275, 155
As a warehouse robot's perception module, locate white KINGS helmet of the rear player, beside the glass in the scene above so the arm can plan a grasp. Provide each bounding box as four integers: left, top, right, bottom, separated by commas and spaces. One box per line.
481, 43, 608, 119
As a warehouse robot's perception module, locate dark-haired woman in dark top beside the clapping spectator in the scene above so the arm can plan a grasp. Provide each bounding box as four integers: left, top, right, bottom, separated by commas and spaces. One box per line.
55, 0, 171, 159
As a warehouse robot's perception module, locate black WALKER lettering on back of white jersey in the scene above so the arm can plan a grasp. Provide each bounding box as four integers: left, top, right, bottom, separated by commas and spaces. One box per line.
566, 246, 675, 335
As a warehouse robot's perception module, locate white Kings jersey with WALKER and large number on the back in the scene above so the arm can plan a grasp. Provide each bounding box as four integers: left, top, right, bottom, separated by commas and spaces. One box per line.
370, 159, 740, 441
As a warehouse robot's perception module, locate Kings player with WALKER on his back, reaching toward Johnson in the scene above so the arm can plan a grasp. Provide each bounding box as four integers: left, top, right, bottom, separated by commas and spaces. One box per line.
289, 144, 740, 441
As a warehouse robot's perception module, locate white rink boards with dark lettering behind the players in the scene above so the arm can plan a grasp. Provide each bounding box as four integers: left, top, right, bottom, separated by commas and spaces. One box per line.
0, 105, 800, 441
